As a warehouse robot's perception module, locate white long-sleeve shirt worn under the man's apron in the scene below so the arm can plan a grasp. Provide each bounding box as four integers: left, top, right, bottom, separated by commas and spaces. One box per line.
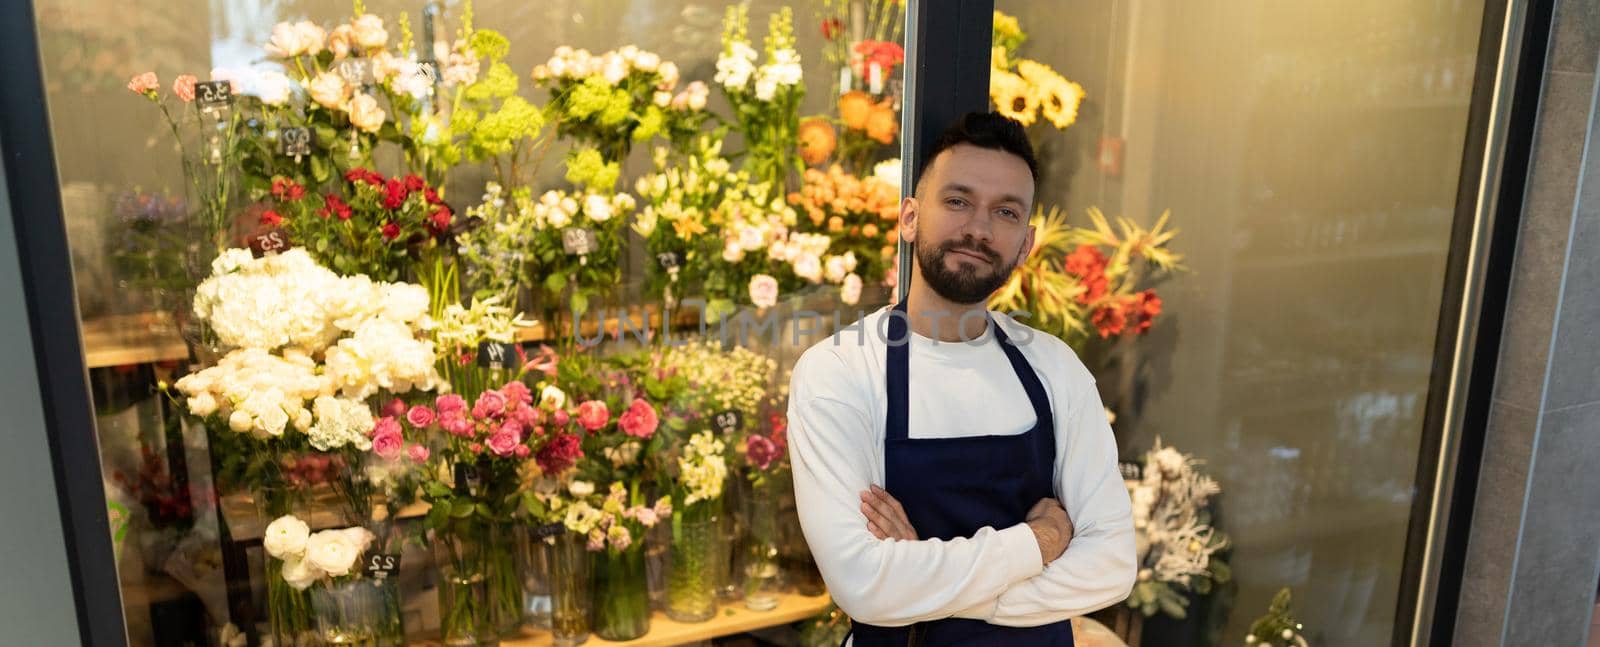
789, 309, 1136, 626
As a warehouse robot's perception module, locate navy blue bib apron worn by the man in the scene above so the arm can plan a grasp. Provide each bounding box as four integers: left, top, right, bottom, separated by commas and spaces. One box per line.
845, 301, 1072, 647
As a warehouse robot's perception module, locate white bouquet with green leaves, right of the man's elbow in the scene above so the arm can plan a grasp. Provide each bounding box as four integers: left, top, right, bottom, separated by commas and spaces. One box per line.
1126, 439, 1232, 620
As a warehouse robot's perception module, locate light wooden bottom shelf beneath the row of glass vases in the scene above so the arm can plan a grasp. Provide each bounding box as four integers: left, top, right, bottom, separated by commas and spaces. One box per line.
411, 593, 832, 647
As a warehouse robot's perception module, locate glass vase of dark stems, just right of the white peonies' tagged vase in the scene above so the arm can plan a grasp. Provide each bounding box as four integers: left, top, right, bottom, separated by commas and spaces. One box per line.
434, 520, 499, 647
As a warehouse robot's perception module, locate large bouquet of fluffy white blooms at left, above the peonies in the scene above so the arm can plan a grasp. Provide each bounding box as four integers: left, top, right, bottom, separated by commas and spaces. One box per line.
173, 248, 442, 520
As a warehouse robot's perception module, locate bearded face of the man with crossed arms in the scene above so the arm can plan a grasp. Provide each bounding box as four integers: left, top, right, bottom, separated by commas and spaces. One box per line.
901, 144, 1034, 304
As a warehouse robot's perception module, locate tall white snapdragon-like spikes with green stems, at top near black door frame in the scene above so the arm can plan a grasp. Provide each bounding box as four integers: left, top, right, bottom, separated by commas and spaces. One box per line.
714, 5, 805, 192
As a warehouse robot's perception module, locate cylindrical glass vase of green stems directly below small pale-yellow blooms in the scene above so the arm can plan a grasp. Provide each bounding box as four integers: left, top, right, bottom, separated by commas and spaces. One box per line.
667, 498, 722, 623
